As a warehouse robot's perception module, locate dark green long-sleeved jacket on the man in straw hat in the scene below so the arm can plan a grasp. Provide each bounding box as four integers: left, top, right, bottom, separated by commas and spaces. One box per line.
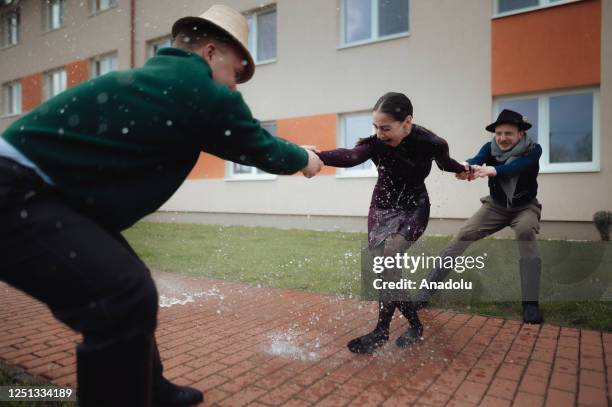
2, 48, 308, 230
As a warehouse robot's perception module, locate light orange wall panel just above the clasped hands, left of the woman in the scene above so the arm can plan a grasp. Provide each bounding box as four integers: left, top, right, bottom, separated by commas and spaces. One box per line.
276, 114, 336, 175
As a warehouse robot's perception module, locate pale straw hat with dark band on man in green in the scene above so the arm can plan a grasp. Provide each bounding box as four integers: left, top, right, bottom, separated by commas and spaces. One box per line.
172, 4, 255, 83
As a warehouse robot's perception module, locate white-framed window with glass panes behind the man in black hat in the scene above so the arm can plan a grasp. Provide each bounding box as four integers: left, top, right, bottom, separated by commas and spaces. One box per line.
497, 89, 599, 172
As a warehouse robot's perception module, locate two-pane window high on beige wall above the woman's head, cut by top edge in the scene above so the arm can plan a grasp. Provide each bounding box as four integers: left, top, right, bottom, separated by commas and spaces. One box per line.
341, 0, 409, 45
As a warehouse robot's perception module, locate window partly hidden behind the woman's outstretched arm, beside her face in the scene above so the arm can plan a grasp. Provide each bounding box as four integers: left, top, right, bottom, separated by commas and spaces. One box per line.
338, 112, 376, 177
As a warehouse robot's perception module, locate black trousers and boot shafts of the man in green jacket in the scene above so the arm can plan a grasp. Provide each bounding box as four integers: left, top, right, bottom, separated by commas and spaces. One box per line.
0, 157, 162, 406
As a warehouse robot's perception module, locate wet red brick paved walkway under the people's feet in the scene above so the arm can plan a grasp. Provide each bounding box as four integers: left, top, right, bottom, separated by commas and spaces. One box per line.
0, 273, 612, 407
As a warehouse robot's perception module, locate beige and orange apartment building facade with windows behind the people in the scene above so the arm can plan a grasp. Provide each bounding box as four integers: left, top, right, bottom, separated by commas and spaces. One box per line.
0, 0, 612, 239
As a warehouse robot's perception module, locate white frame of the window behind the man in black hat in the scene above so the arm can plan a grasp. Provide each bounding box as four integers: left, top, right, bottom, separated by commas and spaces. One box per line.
493, 87, 601, 174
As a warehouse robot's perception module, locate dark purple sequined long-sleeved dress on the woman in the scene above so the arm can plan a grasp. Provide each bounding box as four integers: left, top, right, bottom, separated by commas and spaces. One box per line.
319, 125, 464, 250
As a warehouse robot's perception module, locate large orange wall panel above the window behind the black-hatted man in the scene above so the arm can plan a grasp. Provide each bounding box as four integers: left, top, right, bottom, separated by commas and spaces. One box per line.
491, 0, 601, 96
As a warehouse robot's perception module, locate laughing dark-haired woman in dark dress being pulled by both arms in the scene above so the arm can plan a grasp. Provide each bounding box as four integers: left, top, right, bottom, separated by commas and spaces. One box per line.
318, 92, 469, 353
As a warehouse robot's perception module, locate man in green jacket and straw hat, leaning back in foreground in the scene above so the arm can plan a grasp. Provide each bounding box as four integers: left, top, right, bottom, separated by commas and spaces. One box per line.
0, 6, 322, 406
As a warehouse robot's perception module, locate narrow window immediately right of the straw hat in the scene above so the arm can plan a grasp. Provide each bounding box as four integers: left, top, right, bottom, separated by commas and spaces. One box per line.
247, 8, 276, 63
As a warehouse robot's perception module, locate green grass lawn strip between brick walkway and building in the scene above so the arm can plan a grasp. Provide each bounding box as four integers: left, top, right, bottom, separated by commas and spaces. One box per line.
120, 222, 612, 331
